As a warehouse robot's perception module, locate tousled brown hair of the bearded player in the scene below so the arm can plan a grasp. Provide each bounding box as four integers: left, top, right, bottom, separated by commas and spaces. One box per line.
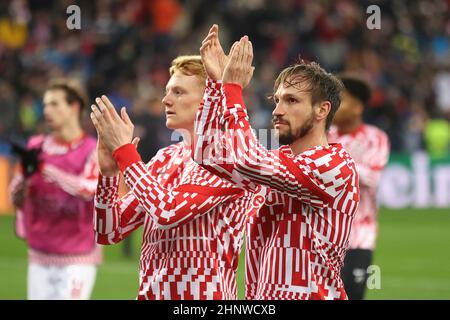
273, 59, 344, 130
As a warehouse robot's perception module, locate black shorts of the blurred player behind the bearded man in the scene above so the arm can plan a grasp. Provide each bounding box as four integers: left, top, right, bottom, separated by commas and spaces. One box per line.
341, 249, 373, 300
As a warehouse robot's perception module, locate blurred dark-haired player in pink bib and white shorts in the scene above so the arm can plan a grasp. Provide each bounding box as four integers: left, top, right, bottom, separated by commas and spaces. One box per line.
11, 81, 101, 300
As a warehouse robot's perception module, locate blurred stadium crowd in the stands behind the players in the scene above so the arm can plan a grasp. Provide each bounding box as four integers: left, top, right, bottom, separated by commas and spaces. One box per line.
0, 0, 450, 158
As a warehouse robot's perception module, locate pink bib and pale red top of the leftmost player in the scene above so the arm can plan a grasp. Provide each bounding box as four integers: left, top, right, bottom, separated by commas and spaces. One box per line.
11, 135, 101, 265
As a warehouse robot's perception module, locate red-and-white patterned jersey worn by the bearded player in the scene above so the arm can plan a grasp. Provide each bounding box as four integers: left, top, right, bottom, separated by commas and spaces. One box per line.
193, 80, 359, 300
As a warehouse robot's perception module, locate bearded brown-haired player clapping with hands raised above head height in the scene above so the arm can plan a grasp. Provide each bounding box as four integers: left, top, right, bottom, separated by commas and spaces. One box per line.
193, 26, 359, 300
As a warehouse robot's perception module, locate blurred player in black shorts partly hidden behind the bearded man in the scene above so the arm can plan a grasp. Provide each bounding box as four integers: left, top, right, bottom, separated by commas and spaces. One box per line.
328, 75, 389, 300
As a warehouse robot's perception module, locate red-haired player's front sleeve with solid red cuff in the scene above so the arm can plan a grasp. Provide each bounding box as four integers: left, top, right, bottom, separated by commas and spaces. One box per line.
113, 144, 242, 229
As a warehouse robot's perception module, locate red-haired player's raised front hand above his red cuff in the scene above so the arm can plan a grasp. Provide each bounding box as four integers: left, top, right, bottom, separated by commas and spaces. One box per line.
91, 95, 134, 154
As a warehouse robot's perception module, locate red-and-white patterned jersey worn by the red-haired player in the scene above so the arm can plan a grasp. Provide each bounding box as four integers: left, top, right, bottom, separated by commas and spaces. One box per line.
95, 142, 266, 300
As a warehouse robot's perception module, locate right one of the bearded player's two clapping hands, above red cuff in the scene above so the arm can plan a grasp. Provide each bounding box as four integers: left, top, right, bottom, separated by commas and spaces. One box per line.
222, 36, 255, 88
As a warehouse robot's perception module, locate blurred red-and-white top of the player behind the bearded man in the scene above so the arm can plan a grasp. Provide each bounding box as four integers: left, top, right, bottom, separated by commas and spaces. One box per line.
328, 124, 389, 250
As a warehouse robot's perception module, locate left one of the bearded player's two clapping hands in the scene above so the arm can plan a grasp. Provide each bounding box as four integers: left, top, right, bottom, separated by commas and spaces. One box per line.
200, 24, 228, 80
